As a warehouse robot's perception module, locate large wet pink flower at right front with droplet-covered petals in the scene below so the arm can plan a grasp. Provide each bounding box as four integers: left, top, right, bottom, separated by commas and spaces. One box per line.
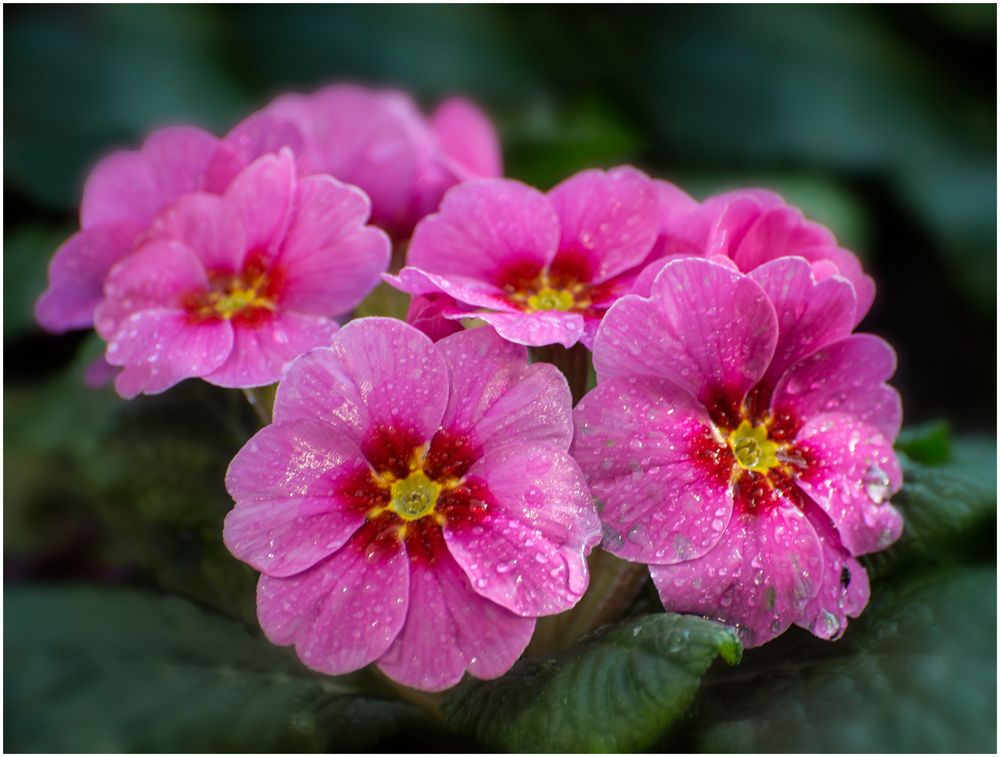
573, 257, 902, 646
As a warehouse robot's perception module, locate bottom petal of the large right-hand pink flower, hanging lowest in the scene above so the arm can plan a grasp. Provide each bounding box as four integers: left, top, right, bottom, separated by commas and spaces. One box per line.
649, 502, 823, 647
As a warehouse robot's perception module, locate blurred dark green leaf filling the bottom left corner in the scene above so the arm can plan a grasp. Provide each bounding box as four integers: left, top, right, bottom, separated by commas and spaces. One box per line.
4, 587, 428, 752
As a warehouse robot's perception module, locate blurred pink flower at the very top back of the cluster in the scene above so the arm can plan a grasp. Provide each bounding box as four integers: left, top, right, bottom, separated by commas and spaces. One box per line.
219, 84, 501, 237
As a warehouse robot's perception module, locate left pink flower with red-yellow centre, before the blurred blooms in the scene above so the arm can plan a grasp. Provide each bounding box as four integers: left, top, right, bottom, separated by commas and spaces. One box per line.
95, 150, 389, 397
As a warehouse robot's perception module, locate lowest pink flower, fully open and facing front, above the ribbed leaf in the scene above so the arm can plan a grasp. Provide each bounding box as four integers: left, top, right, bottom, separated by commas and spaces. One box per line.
225, 318, 599, 691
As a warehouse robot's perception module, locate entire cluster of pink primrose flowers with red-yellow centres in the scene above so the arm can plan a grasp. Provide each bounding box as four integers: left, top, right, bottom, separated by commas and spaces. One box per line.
37, 85, 902, 691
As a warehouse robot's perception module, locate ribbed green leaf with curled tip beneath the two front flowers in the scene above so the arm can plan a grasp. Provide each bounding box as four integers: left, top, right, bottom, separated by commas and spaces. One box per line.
442, 614, 741, 752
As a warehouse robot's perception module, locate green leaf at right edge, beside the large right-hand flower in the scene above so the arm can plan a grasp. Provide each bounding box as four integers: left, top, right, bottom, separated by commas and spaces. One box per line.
866, 432, 997, 577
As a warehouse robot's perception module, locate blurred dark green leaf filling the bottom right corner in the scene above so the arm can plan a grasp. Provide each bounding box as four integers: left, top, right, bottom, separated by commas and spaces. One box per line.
676, 566, 997, 753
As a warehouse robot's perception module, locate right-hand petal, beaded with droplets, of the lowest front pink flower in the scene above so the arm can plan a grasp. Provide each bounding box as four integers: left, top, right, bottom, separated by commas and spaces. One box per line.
444, 442, 600, 616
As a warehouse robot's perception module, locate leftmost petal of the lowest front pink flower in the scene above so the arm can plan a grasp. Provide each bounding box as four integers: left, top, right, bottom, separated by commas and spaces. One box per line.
223, 419, 371, 576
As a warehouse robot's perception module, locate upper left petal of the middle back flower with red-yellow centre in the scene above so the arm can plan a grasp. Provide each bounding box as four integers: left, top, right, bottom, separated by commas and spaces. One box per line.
406, 179, 559, 283
